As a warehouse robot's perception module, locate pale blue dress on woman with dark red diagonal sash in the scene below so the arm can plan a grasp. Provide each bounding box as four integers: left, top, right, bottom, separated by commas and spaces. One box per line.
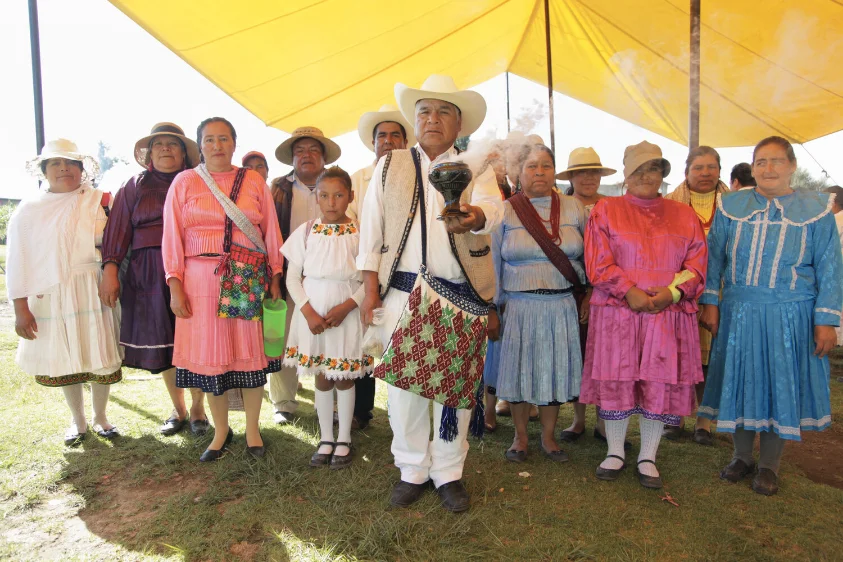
484, 195, 587, 406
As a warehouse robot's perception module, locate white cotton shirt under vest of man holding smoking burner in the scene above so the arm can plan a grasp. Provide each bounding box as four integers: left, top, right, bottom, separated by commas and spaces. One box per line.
357, 145, 503, 283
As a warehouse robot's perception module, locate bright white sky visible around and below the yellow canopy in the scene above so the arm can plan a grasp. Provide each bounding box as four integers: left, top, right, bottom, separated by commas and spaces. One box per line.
0, 0, 843, 197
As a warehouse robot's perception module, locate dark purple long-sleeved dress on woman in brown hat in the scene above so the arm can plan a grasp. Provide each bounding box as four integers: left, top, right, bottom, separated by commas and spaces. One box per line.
102, 170, 177, 373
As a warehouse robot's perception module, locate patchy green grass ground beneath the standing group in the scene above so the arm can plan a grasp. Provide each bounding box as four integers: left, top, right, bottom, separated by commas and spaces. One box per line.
0, 324, 843, 561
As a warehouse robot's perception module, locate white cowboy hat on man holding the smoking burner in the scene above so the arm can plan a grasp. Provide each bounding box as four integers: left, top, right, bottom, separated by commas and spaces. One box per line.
395, 74, 486, 137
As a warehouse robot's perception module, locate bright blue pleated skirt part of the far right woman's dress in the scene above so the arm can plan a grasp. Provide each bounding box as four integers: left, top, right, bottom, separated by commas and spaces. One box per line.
699, 296, 831, 441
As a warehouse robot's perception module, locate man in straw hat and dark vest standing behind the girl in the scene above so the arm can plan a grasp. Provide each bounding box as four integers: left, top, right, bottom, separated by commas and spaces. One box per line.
269, 127, 341, 424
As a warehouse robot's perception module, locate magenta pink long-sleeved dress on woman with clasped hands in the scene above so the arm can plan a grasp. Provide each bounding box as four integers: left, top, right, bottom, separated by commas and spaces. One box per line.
580, 193, 708, 423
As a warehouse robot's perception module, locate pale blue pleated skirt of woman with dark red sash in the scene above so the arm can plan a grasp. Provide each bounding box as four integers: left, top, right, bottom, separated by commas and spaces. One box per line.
487, 292, 582, 406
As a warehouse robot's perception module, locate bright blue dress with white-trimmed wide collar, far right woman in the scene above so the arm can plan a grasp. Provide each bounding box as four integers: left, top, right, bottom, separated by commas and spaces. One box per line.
699, 189, 843, 441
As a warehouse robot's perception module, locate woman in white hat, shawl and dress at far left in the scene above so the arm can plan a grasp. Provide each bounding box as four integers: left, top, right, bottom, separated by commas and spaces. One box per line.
6, 139, 123, 446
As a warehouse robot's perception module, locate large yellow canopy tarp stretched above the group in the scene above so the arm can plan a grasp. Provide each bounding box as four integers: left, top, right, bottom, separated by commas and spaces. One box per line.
111, 0, 843, 146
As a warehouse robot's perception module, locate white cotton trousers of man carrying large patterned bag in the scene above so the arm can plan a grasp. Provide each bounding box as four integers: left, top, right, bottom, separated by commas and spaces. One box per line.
379, 288, 472, 488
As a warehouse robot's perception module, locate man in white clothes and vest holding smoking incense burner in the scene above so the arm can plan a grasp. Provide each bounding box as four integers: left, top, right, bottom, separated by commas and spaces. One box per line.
357, 75, 503, 512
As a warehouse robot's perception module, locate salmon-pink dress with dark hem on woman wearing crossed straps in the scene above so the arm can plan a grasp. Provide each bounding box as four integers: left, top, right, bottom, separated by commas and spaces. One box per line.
161, 168, 284, 395
